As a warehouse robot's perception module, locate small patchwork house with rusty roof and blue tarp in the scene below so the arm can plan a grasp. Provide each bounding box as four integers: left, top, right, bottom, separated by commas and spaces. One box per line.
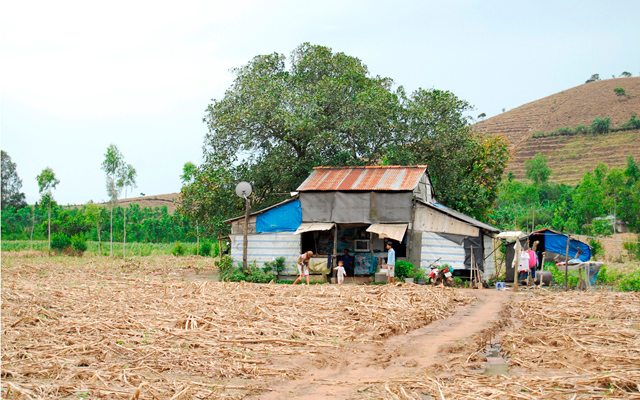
226, 165, 498, 279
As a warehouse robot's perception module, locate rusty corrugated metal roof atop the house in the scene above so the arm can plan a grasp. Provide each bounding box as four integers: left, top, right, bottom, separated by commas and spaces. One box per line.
297, 165, 427, 192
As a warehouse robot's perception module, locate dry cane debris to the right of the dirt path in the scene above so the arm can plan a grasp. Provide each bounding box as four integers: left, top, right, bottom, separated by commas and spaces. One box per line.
364, 292, 640, 400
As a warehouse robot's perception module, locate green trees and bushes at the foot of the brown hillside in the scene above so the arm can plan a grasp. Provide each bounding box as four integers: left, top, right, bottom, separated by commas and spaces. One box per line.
491, 154, 640, 235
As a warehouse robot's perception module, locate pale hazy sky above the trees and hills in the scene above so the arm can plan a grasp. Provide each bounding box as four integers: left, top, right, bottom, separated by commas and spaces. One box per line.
0, 0, 640, 204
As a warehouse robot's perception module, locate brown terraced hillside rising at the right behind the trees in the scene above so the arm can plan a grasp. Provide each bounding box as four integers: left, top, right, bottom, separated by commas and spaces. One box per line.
475, 77, 640, 184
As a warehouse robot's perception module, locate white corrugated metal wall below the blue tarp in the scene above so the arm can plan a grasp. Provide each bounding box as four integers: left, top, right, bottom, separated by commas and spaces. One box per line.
229, 232, 301, 275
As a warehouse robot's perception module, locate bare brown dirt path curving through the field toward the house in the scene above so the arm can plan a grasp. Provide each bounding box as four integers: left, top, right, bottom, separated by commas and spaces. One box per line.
251, 289, 511, 400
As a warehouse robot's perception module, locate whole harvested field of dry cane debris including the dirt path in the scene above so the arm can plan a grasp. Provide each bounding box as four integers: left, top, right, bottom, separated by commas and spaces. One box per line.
2, 251, 640, 399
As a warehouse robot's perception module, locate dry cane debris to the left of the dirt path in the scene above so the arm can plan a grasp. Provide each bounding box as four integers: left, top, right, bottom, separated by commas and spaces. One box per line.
2, 254, 471, 399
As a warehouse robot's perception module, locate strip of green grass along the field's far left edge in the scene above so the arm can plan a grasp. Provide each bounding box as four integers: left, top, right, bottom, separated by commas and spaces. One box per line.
2, 240, 218, 256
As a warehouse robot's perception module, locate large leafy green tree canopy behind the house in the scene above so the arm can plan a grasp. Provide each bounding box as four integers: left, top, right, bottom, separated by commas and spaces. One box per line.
181, 43, 508, 236
